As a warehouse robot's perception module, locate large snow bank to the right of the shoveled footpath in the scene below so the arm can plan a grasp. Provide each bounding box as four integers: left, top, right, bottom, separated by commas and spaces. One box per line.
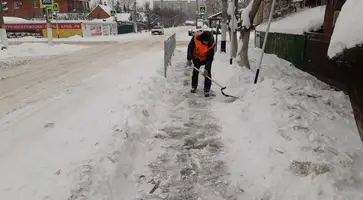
210, 48, 363, 200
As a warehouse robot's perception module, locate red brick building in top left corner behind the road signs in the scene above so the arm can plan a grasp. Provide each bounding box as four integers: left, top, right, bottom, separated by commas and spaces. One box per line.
6, 0, 90, 18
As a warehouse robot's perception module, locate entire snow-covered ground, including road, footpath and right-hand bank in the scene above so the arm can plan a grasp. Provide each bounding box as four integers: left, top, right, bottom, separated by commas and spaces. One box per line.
0, 27, 363, 200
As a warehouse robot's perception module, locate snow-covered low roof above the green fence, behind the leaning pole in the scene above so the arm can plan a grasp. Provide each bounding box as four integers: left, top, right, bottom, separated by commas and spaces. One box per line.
256, 5, 328, 35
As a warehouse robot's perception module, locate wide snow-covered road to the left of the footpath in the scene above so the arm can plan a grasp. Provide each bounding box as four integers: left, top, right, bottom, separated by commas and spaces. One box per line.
0, 29, 191, 200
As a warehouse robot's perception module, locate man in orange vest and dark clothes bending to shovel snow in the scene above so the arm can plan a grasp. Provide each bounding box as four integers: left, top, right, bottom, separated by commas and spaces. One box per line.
187, 31, 215, 97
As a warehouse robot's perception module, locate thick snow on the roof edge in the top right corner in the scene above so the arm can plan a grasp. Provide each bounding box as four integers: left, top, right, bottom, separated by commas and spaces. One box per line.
328, 0, 363, 58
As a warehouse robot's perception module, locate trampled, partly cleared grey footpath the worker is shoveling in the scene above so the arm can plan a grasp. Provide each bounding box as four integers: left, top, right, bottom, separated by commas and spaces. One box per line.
139, 55, 241, 200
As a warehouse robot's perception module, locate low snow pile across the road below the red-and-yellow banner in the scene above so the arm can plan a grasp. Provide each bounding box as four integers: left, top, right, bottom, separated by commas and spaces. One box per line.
0, 43, 86, 60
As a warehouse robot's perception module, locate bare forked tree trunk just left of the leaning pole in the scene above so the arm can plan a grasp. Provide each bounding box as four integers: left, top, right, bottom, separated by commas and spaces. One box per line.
239, 0, 262, 69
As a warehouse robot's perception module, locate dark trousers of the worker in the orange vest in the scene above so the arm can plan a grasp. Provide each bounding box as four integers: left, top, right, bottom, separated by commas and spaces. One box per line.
192, 59, 212, 92
